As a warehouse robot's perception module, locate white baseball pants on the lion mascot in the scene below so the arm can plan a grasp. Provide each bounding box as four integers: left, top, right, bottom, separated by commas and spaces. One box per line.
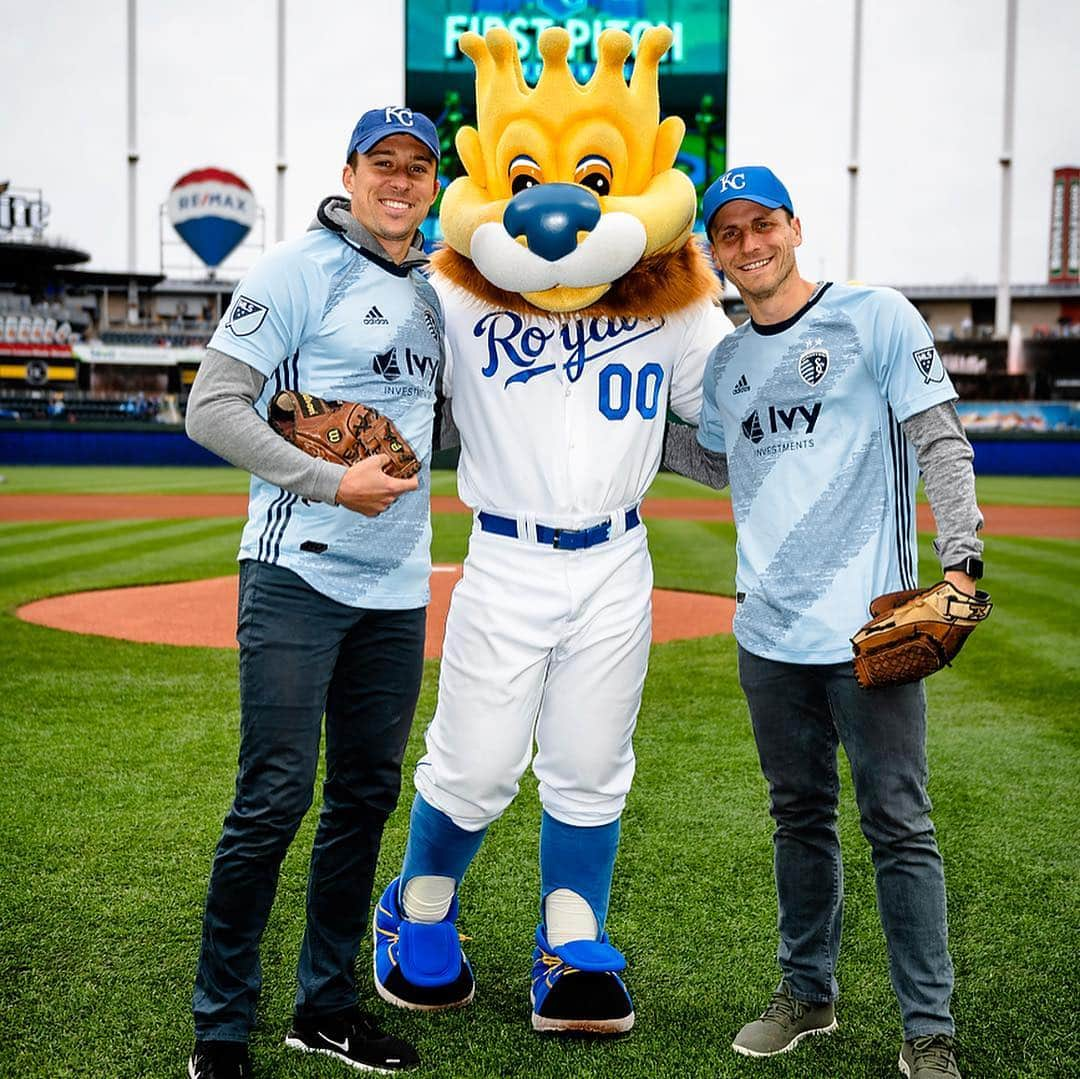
416, 524, 652, 831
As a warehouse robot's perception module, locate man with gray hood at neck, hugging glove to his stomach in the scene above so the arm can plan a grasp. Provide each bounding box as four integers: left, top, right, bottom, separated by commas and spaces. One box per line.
187, 107, 443, 1079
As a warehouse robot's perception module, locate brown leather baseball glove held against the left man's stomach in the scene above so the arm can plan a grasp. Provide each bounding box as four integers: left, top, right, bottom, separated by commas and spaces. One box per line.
268, 390, 420, 480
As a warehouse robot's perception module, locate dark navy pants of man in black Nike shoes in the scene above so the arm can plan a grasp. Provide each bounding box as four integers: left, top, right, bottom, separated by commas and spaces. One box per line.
192, 561, 424, 1041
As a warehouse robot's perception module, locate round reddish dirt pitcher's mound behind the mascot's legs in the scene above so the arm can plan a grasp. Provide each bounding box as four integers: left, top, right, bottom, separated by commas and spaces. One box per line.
16, 566, 735, 657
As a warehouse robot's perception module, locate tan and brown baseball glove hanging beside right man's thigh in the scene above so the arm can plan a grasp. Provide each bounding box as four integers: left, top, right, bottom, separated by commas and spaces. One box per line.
851, 581, 994, 689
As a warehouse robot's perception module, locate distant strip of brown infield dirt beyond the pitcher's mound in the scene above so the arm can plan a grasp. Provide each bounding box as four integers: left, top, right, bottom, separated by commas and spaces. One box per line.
0, 495, 1080, 539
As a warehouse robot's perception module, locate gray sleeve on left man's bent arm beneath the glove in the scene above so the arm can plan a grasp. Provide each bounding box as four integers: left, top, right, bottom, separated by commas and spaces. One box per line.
185, 349, 346, 505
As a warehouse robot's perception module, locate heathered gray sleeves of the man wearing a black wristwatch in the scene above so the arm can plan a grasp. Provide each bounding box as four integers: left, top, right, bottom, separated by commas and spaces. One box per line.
663, 401, 983, 568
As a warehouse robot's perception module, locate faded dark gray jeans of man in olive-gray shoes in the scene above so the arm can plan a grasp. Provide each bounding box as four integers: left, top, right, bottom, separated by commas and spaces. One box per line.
739, 648, 953, 1038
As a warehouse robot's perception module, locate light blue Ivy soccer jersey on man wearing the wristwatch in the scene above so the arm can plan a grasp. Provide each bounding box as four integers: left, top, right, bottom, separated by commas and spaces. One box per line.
698, 284, 956, 663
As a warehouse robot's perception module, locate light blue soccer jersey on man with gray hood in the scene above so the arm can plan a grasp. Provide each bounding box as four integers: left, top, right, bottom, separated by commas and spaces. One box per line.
210, 229, 443, 609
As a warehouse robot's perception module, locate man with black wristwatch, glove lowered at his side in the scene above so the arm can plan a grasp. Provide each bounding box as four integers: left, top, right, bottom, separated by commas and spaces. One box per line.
698, 166, 983, 1079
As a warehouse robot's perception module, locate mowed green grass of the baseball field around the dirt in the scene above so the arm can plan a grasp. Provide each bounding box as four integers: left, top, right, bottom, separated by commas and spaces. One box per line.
0, 468, 1080, 1079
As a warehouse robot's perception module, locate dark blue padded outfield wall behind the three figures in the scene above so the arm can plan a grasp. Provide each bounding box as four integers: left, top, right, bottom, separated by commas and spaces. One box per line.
0, 421, 1080, 476
